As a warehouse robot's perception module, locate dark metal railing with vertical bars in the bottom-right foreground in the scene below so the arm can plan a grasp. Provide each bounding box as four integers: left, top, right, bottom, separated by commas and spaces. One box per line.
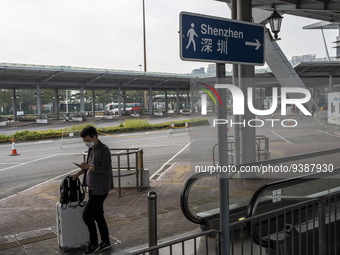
129, 192, 340, 255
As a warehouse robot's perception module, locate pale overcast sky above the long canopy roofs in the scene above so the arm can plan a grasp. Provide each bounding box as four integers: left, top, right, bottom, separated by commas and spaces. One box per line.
0, 0, 338, 73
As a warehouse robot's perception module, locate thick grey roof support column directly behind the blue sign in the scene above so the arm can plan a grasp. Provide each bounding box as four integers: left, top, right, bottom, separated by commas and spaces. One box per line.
237, 0, 256, 164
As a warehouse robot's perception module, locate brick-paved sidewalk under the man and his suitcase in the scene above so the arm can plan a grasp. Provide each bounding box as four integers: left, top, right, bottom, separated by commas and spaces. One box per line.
0, 163, 199, 255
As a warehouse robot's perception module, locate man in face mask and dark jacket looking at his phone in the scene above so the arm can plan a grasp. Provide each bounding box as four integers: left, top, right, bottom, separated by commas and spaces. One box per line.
74, 126, 113, 254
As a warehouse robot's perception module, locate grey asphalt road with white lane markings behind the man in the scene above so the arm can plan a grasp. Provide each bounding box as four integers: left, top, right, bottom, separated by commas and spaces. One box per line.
0, 116, 340, 199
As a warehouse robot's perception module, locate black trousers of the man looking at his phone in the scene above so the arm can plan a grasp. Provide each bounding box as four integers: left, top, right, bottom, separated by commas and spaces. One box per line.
83, 191, 110, 245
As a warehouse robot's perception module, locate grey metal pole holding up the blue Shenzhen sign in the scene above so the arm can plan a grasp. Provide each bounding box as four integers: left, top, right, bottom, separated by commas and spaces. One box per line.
216, 64, 230, 255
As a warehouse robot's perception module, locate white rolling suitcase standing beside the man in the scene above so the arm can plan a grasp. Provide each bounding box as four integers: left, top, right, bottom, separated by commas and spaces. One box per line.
56, 201, 90, 251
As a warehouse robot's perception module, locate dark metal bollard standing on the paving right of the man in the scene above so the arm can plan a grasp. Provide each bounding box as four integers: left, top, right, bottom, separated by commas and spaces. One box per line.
148, 190, 158, 255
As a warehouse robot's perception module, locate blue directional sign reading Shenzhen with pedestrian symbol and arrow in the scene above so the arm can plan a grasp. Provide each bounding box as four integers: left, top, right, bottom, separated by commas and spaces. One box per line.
180, 12, 264, 65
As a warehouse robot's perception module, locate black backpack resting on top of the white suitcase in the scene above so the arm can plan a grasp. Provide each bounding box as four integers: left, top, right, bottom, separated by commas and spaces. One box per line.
60, 175, 85, 209
